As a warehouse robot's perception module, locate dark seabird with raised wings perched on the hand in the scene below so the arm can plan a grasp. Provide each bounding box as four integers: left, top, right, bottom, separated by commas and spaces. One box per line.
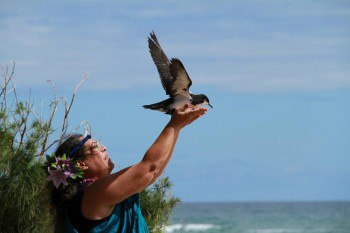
143, 31, 213, 115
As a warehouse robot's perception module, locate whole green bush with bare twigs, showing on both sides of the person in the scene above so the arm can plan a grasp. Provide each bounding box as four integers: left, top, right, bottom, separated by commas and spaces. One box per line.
0, 64, 180, 233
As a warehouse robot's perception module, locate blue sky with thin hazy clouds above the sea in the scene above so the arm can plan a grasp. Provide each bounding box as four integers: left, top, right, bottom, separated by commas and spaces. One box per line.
0, 0, 350, 201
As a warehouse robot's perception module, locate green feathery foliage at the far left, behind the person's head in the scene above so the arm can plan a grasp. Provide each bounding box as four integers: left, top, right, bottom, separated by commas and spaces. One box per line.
0, 99, 52, 233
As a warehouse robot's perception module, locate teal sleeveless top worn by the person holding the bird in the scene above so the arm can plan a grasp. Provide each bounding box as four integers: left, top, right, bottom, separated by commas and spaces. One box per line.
64, 193, 149, 233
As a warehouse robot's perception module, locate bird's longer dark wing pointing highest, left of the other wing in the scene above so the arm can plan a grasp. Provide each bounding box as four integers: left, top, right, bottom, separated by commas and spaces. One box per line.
148, 32, 173, 95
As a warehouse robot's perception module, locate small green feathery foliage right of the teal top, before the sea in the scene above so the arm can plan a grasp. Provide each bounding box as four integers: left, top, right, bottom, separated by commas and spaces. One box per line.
140, 177, 180, 233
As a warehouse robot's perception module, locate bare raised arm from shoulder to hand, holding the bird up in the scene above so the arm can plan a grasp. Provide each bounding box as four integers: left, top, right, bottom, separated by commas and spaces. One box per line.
82, 105, 207, 219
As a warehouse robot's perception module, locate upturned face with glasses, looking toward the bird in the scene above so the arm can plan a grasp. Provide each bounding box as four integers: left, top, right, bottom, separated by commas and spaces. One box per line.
81, 137, 114, 178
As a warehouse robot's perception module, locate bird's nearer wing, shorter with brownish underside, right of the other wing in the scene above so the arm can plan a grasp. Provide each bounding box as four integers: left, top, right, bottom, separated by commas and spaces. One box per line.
170, 58, 192, 99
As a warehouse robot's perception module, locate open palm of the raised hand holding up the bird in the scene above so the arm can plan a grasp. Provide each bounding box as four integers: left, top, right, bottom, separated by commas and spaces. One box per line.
169, 104, 208, 129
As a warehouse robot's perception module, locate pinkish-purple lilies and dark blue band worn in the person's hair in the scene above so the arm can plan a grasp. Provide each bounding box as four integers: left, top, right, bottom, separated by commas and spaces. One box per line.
46, 135, 91, 189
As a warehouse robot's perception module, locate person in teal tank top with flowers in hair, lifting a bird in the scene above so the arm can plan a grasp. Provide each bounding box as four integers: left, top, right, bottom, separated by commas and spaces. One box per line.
49, 104, 207, 233
